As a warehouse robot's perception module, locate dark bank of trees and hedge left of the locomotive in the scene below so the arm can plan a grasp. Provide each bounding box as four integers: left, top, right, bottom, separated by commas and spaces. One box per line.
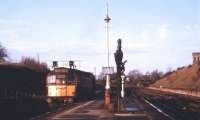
0, 44, 48, 98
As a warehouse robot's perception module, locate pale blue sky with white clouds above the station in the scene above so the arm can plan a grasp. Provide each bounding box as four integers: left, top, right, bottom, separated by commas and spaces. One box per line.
0, 0, 200, 73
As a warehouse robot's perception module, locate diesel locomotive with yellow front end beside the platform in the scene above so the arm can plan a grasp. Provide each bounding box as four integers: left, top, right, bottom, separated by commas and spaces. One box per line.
47, 62, 95, 103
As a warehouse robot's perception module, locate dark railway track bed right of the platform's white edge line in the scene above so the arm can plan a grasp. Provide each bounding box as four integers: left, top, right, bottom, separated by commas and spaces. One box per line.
140, 88, 200, 120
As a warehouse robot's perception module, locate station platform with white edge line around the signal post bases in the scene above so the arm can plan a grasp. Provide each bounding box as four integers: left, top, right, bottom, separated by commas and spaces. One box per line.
39, 100, 149, 120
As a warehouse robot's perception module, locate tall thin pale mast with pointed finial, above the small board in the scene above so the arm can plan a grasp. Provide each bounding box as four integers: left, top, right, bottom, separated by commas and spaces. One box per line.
104, 1, 111, 67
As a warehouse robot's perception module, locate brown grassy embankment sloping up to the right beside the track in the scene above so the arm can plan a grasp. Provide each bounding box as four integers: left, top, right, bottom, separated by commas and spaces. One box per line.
150, 64, 200, 91
